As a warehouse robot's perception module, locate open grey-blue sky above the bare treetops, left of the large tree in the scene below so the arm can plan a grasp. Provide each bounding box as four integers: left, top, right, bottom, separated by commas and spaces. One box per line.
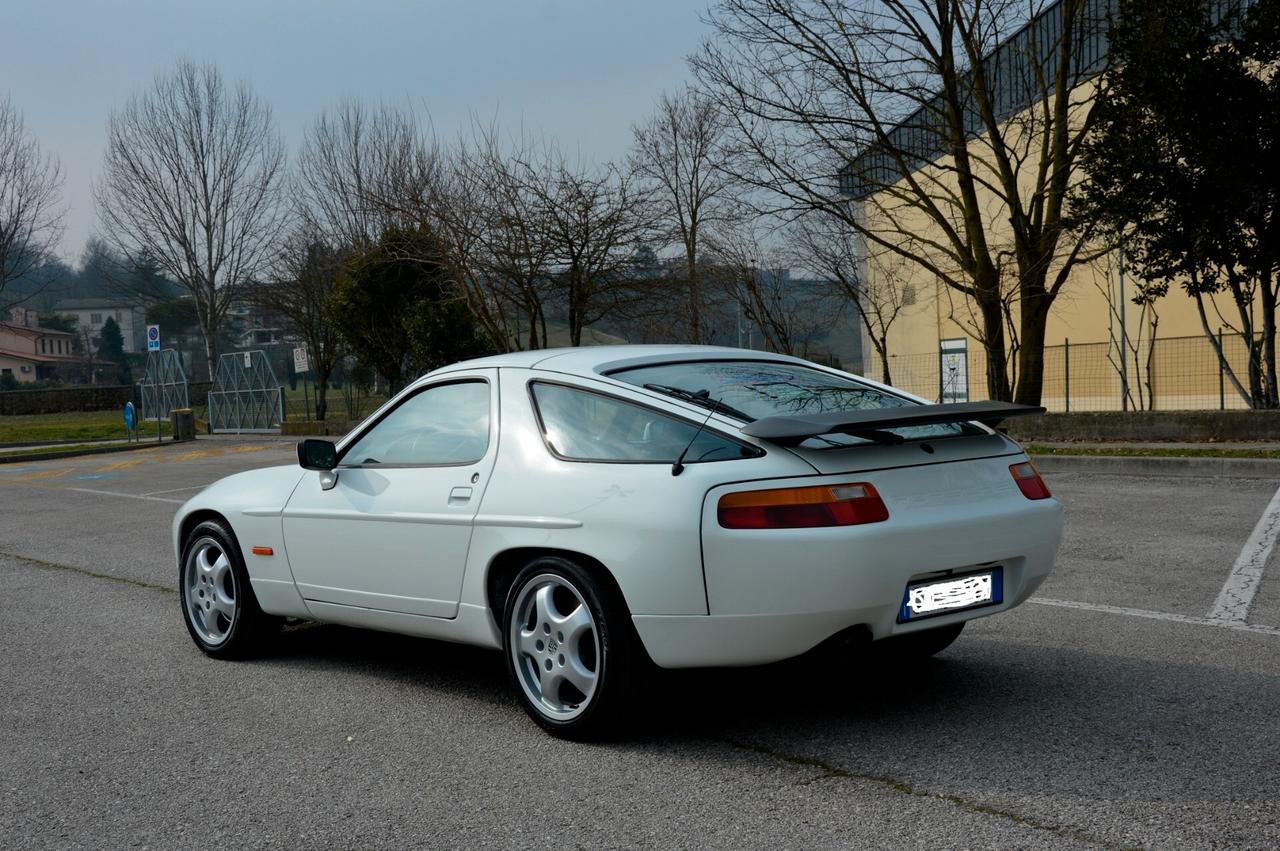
0, 0, 705, 261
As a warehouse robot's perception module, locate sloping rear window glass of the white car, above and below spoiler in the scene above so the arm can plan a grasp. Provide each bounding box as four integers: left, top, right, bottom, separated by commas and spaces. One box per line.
611, 361, 982, 449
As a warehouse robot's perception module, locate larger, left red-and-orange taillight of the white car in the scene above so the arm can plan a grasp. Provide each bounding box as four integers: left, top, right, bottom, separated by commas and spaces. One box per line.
717, 482, 888, 529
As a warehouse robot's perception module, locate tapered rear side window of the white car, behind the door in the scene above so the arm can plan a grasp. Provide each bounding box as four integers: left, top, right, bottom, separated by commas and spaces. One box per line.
530, 383, 760, 463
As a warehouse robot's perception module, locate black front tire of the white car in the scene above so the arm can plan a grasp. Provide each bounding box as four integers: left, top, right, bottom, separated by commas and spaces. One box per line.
178, 520, 283, 659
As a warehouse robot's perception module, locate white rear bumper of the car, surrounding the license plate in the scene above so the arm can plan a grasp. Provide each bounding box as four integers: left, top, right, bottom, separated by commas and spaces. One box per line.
632, 500, 1062, 668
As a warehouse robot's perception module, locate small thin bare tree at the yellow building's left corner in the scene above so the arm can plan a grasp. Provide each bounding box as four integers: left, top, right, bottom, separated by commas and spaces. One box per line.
788, 212, 915, 384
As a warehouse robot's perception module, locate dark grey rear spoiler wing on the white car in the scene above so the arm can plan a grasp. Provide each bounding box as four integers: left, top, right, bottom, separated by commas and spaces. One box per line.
742, 402, 1044, 447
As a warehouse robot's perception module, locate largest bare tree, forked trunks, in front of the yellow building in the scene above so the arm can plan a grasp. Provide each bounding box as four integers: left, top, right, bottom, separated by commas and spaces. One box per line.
691, 0, 1105, 403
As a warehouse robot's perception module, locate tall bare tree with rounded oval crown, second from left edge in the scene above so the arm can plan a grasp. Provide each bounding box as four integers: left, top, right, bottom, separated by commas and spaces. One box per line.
93, 61, 284, 375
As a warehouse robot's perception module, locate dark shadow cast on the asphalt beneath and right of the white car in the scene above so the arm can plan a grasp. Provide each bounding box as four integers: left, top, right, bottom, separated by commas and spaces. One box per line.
247, 624, 1280, 809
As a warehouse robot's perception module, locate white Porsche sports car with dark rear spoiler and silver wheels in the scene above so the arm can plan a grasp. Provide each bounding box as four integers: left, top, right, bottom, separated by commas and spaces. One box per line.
173, 346, 1062, 737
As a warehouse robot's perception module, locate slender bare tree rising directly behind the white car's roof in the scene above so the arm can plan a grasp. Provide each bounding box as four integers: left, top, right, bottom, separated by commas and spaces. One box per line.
631, 88, 737, 343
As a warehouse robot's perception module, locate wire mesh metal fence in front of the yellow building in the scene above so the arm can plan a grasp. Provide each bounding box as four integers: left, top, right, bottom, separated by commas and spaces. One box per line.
885, 334, 1249, 412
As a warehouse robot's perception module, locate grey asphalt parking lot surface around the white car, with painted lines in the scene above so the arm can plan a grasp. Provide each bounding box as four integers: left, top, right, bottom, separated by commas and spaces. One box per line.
0, 438, 1280, 848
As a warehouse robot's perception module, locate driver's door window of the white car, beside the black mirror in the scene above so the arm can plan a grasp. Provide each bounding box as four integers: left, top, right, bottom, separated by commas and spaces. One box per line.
342, 381, 489, 467
